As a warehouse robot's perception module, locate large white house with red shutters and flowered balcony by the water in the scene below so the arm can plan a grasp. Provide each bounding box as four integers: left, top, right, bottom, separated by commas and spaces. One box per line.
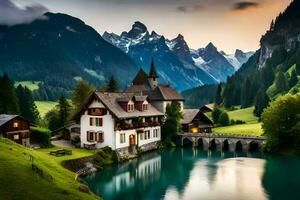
74, 92, 163, 153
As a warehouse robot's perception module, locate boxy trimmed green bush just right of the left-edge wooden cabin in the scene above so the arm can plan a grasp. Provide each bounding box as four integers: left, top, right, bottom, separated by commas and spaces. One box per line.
30, 127, 51, 148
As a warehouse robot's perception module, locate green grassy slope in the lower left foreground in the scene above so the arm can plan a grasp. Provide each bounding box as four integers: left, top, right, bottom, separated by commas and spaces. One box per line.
0, 138, 98, 200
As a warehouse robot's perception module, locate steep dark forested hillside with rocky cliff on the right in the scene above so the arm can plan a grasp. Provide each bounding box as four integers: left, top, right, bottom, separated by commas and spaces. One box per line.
217, 0, 300, 116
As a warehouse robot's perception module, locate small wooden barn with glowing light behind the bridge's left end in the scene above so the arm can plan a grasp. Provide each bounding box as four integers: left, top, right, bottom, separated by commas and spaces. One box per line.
181, 109, 214, 133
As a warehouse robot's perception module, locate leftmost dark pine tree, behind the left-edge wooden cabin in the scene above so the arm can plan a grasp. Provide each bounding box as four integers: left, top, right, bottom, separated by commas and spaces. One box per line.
0, 73, 20, 114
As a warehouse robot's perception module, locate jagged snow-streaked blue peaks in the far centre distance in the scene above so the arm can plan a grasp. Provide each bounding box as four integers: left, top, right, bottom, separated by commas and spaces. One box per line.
102, 22, 253, 90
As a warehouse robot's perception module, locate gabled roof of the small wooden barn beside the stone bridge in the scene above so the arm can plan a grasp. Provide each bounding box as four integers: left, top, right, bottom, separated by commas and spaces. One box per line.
181, 109, 213, 126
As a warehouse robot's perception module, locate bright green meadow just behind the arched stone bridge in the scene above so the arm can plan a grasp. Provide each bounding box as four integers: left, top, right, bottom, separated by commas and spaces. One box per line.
213, 107, 263, 136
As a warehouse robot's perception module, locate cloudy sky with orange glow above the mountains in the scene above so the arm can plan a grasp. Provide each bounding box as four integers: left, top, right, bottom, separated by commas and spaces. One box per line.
9, 0, 291, 53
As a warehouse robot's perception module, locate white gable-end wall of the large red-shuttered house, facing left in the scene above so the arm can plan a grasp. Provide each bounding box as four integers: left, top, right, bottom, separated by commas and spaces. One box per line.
80, 101, 115, 149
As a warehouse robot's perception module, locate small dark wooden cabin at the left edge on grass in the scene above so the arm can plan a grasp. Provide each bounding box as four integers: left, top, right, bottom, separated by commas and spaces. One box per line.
0, 114, 30, 146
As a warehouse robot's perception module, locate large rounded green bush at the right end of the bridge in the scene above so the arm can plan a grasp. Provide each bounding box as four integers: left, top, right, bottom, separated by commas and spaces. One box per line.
262, 94, 300, 152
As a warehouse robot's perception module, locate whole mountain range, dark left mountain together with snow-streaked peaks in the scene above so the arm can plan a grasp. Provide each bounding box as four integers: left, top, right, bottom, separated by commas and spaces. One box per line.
0, 12, 251, 100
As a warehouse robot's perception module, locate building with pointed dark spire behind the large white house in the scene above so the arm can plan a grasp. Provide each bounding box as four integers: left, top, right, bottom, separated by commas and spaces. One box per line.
125, 60, 184, 113
